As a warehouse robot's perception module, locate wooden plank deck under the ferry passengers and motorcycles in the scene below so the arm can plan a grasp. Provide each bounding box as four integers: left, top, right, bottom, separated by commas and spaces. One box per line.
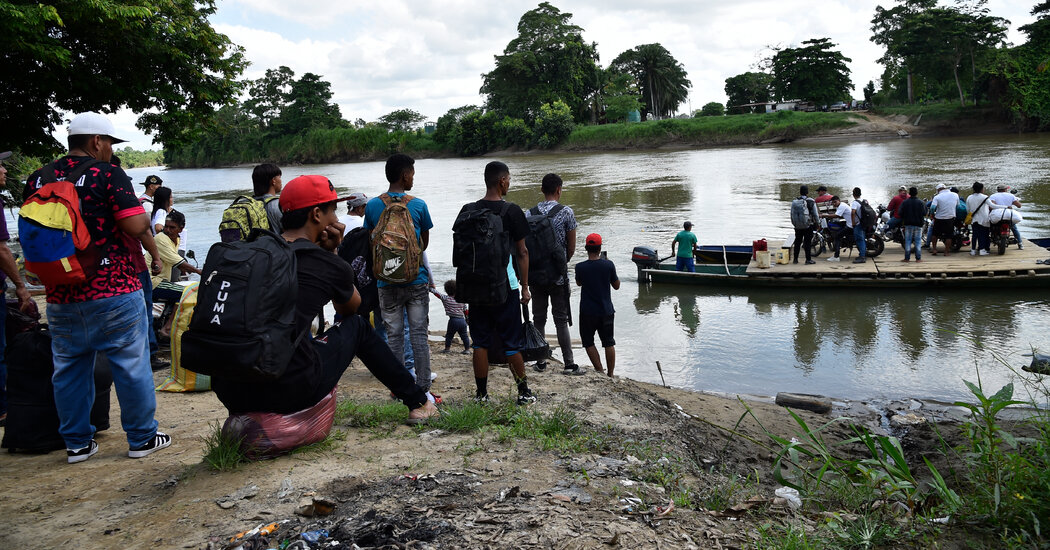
748, 239, 1050, 279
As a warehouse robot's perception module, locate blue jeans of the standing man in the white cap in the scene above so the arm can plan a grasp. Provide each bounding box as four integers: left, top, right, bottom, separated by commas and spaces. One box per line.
47, 290, 156, 449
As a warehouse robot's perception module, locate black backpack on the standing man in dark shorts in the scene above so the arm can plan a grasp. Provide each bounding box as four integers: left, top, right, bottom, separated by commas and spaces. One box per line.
453, 202, 510, 305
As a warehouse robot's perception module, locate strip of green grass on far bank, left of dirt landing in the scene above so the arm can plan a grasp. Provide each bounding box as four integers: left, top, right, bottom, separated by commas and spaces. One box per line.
563, 111, 858, 148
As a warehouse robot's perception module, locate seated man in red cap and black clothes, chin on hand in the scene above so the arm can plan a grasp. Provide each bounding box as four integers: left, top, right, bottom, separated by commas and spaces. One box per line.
212, 175, 438, 423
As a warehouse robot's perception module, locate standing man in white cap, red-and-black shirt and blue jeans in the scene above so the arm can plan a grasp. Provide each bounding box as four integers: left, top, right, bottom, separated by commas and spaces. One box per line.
23, 112, 171, 464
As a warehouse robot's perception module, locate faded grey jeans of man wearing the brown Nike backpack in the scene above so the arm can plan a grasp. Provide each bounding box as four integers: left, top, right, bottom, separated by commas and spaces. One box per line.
379, 284, 431, 392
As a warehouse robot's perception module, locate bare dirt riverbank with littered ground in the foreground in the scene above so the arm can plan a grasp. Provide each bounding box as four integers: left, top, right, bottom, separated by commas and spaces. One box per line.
0, 345, 1041, 549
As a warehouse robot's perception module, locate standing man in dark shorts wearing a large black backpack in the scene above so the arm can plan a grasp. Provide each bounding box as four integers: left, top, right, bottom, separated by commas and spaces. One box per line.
456, 161, 536, 405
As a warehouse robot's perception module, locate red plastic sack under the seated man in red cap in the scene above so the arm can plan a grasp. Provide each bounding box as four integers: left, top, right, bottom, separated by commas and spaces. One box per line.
223, 387, 336, 460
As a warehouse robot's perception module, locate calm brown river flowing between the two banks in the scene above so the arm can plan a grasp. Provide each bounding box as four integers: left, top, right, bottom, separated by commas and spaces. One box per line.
110, 134, 1050, 401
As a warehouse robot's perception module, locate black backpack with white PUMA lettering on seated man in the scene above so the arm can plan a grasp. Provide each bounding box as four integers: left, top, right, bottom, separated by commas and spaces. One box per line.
182, 229, 312, 382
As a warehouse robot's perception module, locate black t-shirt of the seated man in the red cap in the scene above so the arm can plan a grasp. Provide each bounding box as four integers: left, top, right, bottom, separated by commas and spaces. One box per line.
212, 239, 354, 415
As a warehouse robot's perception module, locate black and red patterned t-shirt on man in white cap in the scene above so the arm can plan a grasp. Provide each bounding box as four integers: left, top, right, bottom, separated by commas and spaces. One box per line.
22, 156, 146, 303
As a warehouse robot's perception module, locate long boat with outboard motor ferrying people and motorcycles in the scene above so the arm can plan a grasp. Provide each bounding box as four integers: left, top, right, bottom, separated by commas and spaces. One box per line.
631, 238, 1050, 288
